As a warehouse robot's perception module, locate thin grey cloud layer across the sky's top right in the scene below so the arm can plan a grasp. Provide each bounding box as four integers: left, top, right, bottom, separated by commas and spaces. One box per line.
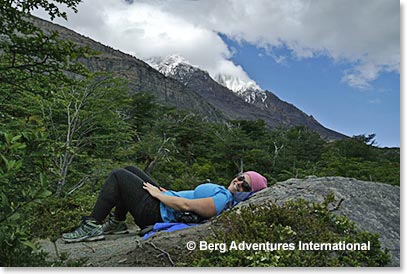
151, 0, 400, 89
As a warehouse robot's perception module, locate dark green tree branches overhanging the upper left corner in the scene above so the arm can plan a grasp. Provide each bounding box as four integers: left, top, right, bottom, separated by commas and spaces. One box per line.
0, 0, 90, 94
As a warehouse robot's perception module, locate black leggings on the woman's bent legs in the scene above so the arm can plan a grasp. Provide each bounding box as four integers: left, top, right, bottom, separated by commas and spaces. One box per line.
90, 166, 163, 228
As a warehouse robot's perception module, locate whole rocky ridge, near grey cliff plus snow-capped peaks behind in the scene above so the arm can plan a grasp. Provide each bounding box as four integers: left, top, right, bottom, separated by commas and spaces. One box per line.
36, 16, 346, 140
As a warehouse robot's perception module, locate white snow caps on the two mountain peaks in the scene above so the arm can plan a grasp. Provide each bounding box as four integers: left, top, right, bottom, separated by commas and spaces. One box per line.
146, 54, 268, 107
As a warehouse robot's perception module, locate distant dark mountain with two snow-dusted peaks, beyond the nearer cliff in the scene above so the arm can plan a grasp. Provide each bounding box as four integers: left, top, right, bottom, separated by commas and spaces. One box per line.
148, 55, 346, 140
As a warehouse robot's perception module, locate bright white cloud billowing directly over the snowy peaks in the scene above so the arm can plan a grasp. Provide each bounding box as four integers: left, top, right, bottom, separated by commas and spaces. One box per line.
37, 0, 255, 81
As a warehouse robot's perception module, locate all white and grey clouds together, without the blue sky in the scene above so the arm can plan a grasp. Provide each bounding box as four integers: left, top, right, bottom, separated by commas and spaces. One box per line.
32, 0, 400, 89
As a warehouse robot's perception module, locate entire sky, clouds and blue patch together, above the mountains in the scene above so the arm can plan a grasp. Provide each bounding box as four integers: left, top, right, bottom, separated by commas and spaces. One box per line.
35, 0, 400, 147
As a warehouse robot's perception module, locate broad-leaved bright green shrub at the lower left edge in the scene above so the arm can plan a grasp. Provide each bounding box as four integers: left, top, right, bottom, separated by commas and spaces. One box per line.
0, 132, 51, 266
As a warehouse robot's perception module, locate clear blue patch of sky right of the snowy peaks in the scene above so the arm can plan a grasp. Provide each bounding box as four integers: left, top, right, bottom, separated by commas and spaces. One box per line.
221, 35, 400, 147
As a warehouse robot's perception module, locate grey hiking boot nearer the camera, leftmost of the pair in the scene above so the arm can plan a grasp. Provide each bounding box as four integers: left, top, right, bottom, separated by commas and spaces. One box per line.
62, 219, 105, 243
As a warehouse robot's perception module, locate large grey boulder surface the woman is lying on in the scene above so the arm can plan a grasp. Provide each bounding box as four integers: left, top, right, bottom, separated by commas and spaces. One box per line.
41, 177, 400, 266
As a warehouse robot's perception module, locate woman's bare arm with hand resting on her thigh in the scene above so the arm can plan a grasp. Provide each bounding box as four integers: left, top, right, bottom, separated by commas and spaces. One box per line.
143, 183, 216, 218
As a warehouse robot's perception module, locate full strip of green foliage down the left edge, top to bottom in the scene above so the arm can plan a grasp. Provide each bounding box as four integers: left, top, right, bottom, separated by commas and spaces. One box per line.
0, 0, 89, 266
